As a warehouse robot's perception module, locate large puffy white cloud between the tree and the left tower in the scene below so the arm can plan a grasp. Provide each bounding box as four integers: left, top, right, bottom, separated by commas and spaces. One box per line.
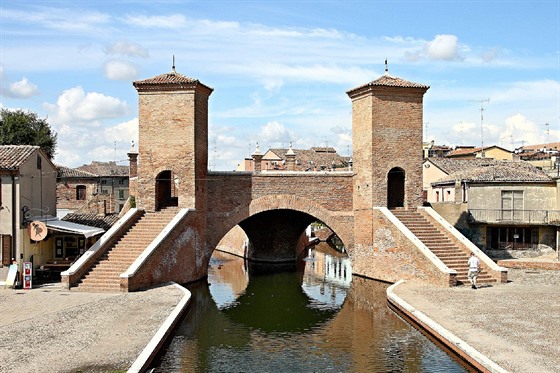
45, 86, 128, 125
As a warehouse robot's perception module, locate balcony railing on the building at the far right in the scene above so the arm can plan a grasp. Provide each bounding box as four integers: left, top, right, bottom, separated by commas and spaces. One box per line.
469, 209, 560, 225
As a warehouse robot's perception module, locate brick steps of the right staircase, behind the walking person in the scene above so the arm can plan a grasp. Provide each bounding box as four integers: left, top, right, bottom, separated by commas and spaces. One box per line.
391, 209, 497, 285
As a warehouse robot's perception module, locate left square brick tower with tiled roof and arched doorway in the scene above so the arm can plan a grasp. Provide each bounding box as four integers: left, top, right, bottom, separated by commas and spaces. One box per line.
133, 67, 212, 211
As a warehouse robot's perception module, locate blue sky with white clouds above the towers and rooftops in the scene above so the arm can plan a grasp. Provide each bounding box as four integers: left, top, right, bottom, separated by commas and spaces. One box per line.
0, 0, 560, 170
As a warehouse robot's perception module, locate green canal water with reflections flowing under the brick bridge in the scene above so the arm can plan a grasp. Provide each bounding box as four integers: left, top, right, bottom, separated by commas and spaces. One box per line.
154, 247, 469, 373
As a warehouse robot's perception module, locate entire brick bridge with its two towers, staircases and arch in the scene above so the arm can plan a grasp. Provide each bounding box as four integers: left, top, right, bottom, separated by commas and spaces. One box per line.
63, 70, 506, 291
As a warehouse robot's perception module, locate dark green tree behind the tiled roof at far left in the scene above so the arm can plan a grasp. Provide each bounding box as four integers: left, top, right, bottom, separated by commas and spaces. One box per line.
0, 109, 57, 159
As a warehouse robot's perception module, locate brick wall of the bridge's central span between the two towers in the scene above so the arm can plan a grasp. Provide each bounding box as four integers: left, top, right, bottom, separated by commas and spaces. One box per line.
207, 172, 353, 250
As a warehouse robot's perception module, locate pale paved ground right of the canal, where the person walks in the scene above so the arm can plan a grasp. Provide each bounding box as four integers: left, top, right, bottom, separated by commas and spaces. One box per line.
393, 269, 560, 373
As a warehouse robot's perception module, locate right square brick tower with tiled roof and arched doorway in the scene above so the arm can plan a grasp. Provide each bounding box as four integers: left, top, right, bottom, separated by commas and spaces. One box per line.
347, 68, 430, 211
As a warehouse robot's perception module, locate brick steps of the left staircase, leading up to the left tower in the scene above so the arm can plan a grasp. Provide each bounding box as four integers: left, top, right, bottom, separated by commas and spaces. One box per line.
73, 208, 178, 292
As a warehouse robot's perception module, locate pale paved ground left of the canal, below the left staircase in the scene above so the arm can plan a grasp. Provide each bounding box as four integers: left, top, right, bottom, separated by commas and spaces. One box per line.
0, 284, 185, 373
